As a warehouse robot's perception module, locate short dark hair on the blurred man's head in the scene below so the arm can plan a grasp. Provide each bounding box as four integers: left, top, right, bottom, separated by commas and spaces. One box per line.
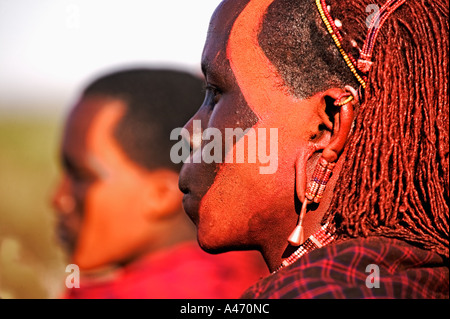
82, 68, 204, 172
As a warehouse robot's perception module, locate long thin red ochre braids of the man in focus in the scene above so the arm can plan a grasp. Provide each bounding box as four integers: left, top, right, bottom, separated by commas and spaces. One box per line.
311, 0, 449, 258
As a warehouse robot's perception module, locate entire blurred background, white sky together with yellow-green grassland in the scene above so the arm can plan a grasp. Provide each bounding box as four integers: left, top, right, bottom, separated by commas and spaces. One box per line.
0, 0, 221, 298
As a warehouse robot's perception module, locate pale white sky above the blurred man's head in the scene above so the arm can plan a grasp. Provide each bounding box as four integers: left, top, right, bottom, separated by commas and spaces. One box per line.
0, 0, 220, 112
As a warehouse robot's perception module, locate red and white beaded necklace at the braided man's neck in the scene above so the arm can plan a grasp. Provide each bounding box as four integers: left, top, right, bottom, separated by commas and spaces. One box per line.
273, 224, 335, 273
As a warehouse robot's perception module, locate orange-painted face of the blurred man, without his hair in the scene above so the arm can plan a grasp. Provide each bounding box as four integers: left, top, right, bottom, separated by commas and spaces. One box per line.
53, 97, 181, 270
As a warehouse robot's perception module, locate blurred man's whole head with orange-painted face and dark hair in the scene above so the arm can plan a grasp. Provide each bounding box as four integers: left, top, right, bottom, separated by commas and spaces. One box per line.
53, 69, 202, 269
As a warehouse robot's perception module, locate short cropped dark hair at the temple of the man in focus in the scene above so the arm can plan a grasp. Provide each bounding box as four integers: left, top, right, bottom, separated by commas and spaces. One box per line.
258, 0, 358, 99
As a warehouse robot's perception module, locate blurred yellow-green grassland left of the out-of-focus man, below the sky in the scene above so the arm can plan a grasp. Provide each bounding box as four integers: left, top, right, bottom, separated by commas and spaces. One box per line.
0, 112, 67, 298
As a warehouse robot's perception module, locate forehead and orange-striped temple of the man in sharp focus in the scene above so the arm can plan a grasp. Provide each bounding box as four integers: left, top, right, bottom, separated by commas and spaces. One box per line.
203, 0, 300, 119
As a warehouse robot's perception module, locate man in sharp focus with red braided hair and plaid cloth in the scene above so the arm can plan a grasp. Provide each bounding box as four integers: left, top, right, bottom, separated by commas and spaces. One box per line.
179, 0, 449, 298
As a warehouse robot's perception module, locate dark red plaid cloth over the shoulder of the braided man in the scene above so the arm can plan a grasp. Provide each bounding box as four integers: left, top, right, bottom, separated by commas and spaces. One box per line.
241, 237, 449, 299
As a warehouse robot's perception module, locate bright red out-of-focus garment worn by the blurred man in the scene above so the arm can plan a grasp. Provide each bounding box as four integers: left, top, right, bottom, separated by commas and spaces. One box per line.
65, 242, 268, 299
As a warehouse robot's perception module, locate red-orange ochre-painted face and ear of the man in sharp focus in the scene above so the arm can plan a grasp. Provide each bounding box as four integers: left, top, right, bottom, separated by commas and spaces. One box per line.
180, 0, 336, 268
